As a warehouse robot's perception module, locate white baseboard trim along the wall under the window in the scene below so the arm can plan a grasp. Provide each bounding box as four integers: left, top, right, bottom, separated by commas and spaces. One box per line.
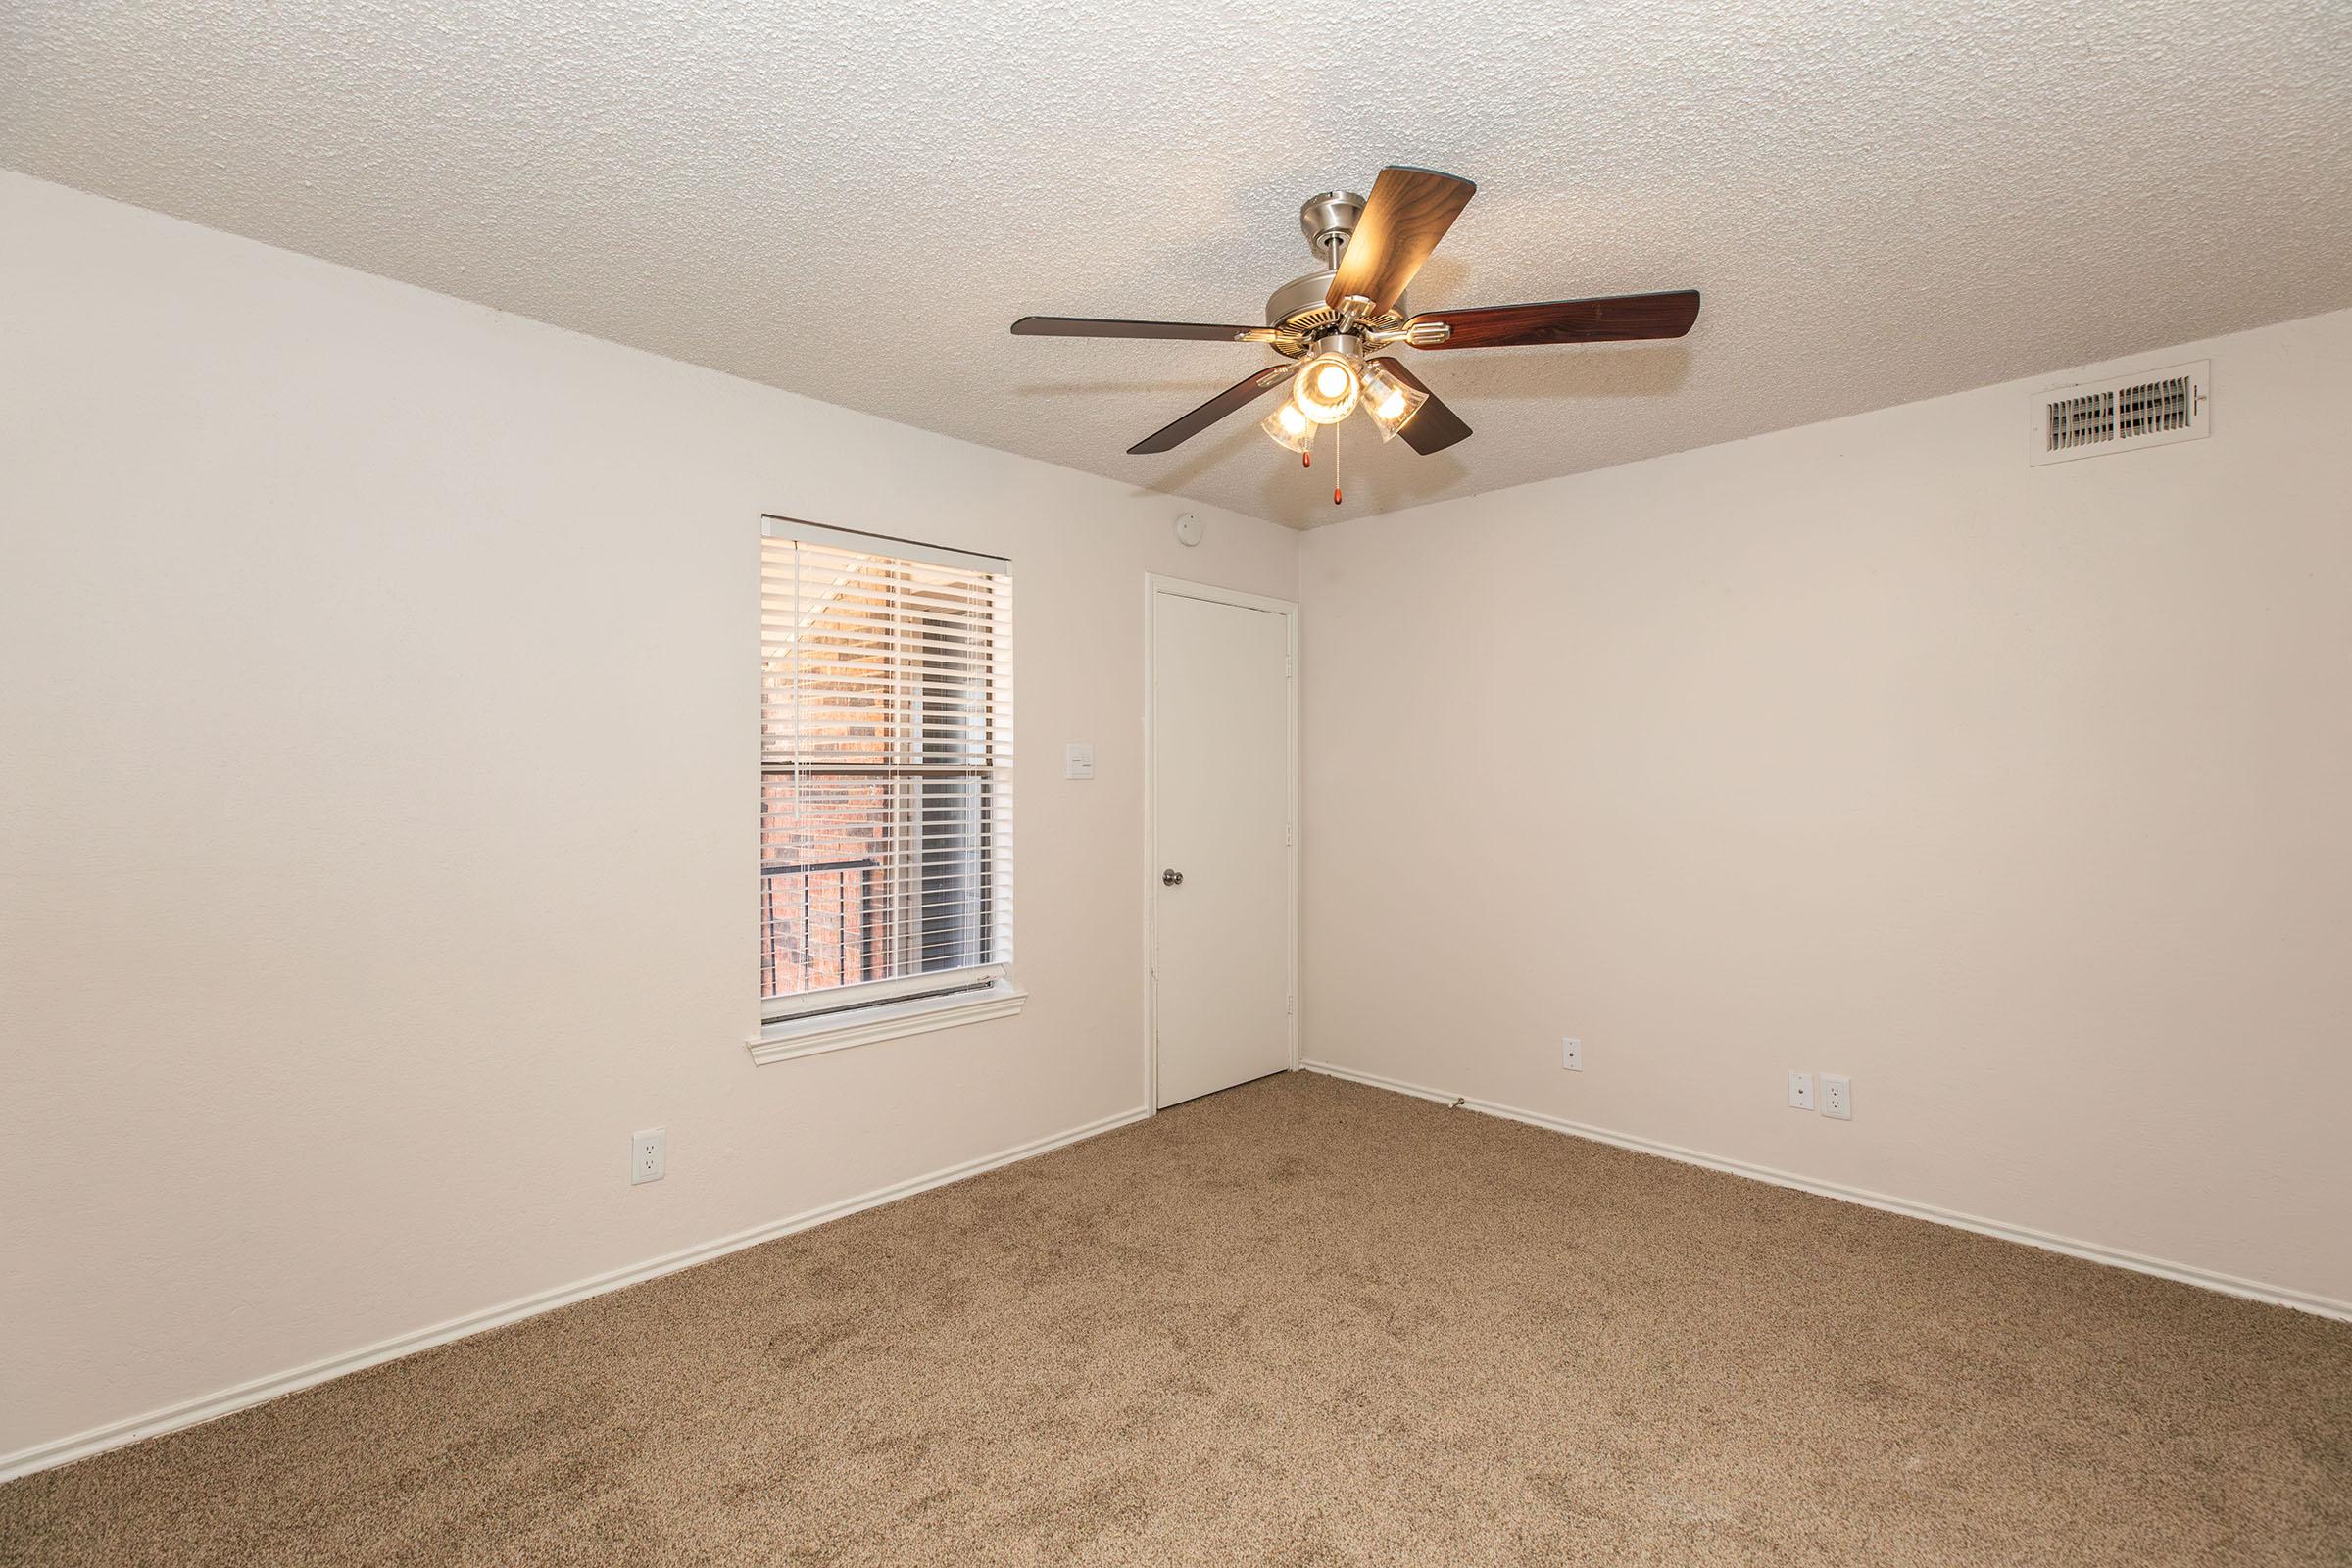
0, 1104, 1152, 1481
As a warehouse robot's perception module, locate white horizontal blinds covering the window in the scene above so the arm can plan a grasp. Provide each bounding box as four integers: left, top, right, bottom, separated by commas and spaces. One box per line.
760, 522, 1013, 1015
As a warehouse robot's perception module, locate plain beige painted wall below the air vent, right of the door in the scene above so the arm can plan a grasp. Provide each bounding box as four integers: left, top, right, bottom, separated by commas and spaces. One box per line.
1300, 313, 2352, 1302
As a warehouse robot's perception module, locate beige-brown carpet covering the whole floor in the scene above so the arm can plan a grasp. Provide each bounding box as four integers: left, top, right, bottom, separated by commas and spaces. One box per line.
0, 1074, 2352, 1568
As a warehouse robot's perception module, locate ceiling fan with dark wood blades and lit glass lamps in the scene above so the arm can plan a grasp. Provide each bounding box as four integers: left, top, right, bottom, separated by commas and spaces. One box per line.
1013, 165, 1698, 503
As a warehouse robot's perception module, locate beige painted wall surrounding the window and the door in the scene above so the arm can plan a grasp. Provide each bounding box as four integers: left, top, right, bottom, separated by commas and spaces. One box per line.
0, 174, 1298, 1455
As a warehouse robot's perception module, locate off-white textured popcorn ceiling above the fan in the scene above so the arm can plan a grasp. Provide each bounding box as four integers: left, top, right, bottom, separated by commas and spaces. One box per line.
0, 0, 2352, 524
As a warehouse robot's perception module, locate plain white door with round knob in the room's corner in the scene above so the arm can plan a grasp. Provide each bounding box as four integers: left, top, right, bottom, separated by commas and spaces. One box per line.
1151, 588, 1292, 1104
